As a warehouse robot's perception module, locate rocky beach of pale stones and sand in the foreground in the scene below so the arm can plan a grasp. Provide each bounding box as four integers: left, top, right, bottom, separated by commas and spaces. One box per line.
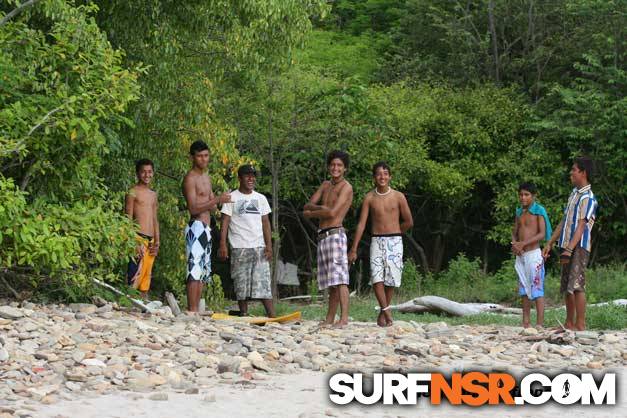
0, 301, 627, 418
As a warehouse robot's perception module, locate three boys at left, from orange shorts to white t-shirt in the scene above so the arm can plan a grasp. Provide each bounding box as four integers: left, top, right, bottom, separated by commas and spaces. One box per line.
126, 141, 275, 317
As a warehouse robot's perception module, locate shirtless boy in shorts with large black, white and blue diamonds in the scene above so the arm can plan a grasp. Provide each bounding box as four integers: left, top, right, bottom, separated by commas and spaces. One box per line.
183, 141, 231, 312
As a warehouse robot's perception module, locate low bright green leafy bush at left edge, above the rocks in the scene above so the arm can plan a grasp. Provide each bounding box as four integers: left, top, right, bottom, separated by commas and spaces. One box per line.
0, 178, 134, 301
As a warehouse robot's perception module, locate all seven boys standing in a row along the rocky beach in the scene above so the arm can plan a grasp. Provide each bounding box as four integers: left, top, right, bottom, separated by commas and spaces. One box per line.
125, 141, 597, 329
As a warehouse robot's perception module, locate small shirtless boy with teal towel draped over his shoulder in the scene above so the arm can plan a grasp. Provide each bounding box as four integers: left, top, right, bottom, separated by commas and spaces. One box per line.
512, 183, 551, 328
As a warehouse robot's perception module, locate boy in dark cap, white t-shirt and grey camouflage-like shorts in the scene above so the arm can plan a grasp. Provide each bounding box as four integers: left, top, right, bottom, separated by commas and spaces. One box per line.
218, 164, 275, 318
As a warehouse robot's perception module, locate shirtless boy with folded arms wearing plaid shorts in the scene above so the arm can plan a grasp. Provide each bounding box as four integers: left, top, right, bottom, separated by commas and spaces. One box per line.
303, 151, 353, 327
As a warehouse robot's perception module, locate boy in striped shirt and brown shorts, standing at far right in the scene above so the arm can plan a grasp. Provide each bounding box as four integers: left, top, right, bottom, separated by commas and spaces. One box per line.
542, 157, 598, 331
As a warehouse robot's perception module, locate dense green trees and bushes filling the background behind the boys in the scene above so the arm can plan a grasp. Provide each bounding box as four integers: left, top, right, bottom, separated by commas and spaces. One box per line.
0, 0, 627, 303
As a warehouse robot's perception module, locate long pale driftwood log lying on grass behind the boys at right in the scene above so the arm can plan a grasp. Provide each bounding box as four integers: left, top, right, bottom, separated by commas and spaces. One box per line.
376, 296, 627, 316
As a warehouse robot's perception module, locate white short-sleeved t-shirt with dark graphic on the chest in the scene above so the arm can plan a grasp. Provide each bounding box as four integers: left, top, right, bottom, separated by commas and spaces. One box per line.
222, 190, 270, 248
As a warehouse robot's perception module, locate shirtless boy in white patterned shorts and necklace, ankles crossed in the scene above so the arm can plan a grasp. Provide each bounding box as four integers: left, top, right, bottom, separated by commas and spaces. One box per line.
348, 161, 414, 327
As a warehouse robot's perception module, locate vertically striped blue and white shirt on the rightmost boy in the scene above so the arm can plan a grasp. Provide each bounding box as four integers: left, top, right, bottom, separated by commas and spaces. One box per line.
558, 184, 598, 252
